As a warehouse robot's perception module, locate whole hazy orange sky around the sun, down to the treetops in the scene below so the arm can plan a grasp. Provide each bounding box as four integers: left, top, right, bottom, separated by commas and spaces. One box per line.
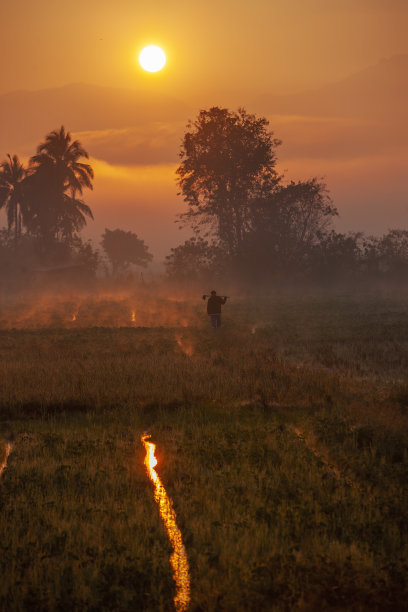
0, 0, 408, 260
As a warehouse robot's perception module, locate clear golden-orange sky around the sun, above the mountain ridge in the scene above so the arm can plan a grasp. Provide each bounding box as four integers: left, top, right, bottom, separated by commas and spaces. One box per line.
0, 0, 408, 97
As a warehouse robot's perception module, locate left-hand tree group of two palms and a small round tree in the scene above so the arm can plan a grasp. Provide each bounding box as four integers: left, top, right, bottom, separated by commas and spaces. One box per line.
0, 126, 152, 276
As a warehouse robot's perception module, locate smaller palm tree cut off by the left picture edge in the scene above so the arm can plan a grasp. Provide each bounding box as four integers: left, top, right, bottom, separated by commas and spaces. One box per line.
0, 154, 26, 245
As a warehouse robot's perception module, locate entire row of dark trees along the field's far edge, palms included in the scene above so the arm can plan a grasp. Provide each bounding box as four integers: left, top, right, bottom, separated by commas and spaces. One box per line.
0, 107, 408, 285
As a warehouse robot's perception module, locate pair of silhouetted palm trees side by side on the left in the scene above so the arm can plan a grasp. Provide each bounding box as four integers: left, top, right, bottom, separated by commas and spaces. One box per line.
0, 126, 94, 244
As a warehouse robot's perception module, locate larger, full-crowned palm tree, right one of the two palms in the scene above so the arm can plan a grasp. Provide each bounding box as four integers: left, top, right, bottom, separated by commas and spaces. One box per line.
29, 126, 94, 239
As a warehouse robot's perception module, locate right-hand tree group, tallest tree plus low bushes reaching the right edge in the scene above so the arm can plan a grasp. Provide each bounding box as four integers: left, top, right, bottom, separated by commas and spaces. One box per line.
166, 107, 408, 284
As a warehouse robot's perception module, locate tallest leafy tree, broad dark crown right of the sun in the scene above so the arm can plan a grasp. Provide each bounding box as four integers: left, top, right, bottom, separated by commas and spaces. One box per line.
176, 107, 280, 255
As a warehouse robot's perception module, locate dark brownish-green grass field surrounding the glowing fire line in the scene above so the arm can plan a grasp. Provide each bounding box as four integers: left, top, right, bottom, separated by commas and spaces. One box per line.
0, 292, 408, 611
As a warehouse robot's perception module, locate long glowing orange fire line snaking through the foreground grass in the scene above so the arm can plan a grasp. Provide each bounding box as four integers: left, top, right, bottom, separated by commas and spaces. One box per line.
141, 434, 190, 612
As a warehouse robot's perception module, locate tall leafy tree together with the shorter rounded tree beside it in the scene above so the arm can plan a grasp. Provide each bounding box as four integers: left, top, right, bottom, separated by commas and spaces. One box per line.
174, 107, 338, 280
